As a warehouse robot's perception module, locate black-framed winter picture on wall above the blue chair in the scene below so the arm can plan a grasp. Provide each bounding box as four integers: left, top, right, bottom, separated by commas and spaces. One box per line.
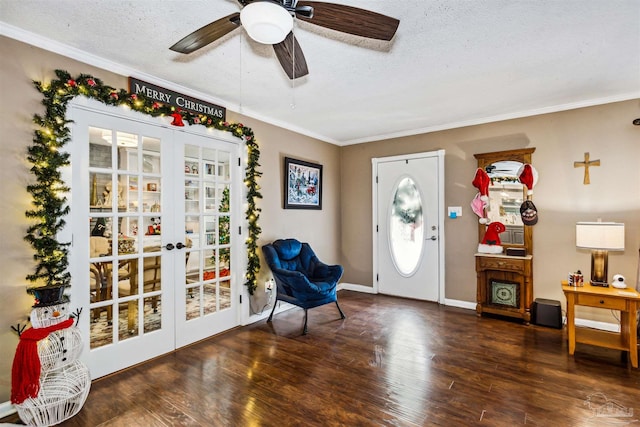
283, 157, 322, 210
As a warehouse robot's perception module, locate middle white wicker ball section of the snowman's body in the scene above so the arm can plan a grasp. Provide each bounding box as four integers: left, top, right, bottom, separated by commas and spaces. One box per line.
38, 326, 82, 374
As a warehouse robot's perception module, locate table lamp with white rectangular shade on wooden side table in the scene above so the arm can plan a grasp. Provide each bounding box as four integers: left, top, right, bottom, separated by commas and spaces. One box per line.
576, 222, 624, 287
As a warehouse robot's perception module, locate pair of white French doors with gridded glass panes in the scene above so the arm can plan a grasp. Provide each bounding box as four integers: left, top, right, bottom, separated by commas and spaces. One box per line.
67, 101, 240, 378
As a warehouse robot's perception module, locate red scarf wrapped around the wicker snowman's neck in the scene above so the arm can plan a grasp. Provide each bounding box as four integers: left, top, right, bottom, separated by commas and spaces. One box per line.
11, 319, 74, 404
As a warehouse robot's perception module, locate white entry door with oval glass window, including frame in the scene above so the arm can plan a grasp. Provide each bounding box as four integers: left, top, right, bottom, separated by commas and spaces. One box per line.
373, 150, 444, 302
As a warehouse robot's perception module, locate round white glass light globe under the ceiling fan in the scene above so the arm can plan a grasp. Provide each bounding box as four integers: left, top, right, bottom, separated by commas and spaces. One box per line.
240, 1, 293, 44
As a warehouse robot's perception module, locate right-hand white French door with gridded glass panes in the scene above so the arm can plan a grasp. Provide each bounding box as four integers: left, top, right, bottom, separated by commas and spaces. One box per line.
173, 132, 240, 347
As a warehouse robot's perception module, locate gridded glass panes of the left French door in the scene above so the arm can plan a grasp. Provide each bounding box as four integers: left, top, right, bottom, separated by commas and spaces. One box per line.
88, 127, 163, 349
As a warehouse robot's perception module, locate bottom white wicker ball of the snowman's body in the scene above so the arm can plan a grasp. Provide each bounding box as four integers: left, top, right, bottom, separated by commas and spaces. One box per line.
15, 360, 91, 426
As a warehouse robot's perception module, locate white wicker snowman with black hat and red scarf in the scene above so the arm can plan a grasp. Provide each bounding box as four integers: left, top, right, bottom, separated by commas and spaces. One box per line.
11, 286, 91, 426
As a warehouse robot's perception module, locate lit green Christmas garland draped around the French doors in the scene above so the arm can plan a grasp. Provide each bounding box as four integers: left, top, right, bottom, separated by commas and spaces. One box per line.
25, 70, 262, 295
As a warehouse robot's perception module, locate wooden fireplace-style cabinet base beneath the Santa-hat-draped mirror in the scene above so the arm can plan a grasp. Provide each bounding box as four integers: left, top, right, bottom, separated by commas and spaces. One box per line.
475, 254, 533, 325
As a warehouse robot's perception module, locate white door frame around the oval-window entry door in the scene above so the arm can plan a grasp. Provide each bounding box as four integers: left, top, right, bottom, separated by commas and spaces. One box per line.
371, 150, 445, 304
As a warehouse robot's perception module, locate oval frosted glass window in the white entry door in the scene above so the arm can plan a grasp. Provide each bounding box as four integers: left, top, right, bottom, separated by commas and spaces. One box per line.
389, 177, 424, 276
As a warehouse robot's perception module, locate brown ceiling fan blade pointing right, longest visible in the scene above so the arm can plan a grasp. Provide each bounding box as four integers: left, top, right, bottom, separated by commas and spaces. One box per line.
297, 1, 400, 40
